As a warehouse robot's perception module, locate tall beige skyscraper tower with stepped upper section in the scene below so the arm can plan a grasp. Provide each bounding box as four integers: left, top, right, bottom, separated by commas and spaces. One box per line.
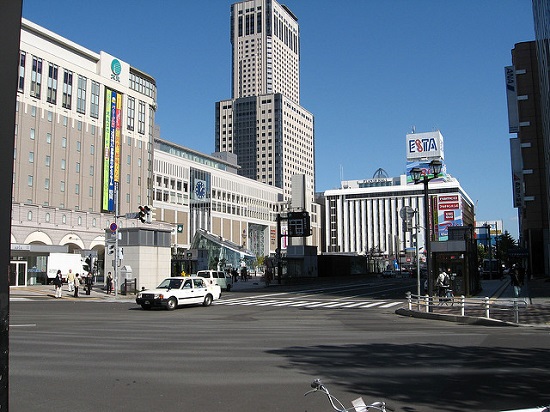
215, 0, 315, 201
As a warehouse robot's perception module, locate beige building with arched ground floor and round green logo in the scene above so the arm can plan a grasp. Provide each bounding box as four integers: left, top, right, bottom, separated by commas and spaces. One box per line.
10, 19, 156, 283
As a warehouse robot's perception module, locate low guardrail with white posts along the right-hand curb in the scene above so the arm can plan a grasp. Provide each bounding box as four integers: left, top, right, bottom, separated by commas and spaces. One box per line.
407, 292, 527, 323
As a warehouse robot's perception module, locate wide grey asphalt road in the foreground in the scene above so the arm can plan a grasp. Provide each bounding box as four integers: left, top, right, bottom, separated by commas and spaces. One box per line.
9, 282, 550, 412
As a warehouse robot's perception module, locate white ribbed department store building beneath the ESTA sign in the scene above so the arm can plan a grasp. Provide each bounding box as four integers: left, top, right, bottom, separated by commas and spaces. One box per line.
325, 175, 474, 259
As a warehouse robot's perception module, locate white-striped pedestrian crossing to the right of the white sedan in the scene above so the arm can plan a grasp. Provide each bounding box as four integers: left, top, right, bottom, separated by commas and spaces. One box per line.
213, 297, 403, 309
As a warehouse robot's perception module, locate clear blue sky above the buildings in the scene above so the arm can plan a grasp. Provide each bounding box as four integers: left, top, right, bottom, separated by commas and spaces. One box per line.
23, 0, 535, 239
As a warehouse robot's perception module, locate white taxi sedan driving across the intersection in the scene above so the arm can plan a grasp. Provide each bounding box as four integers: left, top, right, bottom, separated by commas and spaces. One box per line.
136, 277, 222, 310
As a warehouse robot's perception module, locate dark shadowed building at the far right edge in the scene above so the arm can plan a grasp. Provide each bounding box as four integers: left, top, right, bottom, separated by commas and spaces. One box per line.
505, 41, 550, 274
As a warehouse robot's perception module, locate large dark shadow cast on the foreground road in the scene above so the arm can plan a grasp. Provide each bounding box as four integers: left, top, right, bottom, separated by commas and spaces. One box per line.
269, 343, 550, 411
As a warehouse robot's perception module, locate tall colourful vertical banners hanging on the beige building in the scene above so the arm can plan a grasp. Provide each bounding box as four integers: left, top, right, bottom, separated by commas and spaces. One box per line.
102, 89, 122, 212
